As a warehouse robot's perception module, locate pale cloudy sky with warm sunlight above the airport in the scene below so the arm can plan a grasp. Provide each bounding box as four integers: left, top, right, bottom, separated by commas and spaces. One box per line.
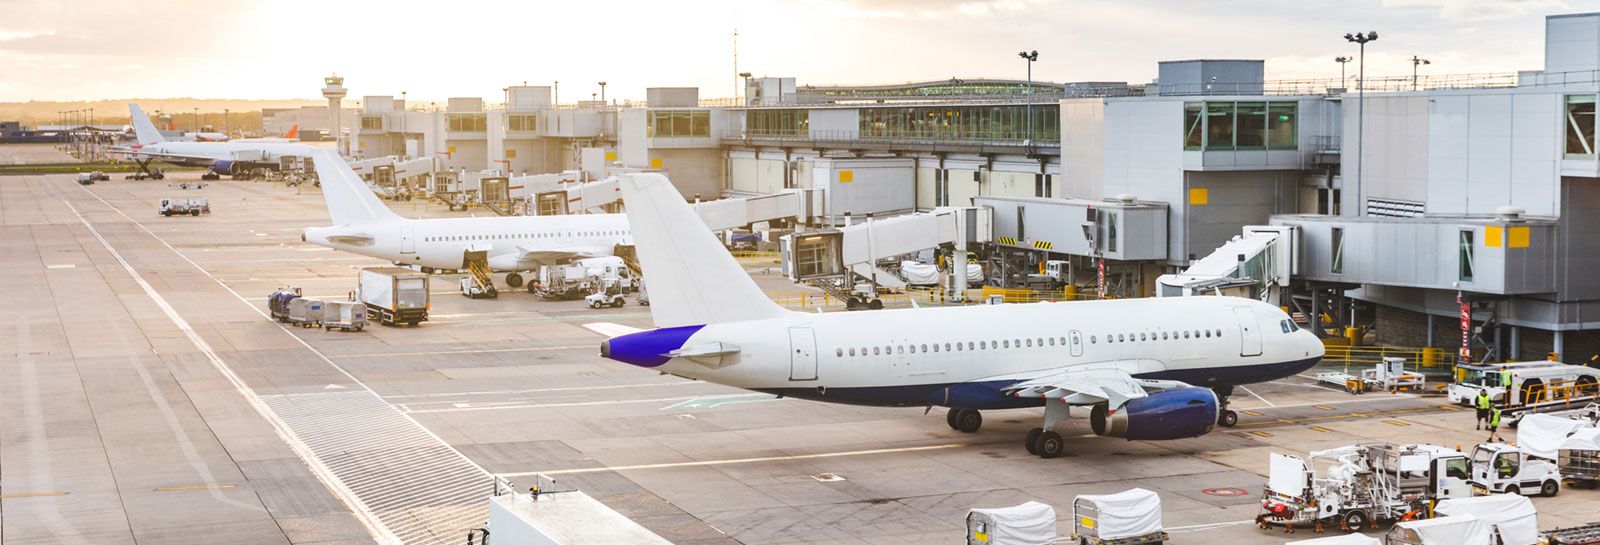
0, 0, 1600, 104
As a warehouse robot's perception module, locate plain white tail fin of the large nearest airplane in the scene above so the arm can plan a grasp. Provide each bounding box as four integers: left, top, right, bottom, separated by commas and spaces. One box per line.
619, 173, 789, 328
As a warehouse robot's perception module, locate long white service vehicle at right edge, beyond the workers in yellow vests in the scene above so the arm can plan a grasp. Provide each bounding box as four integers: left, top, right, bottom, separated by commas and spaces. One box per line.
1445, 360, 1600, 406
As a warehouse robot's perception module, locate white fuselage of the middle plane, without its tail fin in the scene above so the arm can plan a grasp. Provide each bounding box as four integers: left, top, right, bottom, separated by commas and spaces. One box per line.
304, 214, 634, 272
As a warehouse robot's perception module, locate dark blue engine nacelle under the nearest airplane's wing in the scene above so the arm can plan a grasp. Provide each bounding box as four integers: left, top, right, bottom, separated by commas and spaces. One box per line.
1090, 387, 1218, 441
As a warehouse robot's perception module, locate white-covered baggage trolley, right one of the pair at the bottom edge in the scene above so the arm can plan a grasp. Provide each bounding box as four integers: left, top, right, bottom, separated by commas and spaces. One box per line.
1072, 487, 1166, 545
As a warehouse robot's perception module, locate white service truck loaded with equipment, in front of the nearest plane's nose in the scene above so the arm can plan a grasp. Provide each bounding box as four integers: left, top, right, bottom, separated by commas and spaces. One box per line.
1256, 443, 1472, 531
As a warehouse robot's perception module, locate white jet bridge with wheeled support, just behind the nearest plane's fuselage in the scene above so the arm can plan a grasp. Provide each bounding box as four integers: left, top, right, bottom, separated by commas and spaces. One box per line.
779, 206, 994, 292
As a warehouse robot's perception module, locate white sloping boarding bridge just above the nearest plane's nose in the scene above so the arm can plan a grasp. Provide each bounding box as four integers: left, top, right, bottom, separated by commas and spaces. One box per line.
1155, 225, 1299, 305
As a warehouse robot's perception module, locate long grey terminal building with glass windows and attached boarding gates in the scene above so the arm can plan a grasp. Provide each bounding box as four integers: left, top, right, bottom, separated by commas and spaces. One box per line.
278, 14, 1600, 361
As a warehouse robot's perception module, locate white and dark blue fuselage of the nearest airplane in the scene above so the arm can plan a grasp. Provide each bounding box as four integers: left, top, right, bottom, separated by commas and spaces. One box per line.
605, 296, 1323, 409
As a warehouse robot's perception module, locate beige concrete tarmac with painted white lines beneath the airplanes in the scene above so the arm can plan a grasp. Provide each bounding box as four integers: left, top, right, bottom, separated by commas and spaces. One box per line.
0, 147, 1600, 545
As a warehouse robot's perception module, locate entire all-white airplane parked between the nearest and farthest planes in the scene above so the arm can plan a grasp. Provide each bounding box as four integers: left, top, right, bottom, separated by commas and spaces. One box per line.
301, 150, 634, 288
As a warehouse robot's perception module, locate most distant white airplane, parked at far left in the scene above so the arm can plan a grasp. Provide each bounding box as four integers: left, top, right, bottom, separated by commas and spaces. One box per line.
117, 104, 315, 179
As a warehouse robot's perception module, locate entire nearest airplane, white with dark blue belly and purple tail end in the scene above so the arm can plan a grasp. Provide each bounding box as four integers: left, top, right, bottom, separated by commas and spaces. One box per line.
589, 174, 1323, 457
